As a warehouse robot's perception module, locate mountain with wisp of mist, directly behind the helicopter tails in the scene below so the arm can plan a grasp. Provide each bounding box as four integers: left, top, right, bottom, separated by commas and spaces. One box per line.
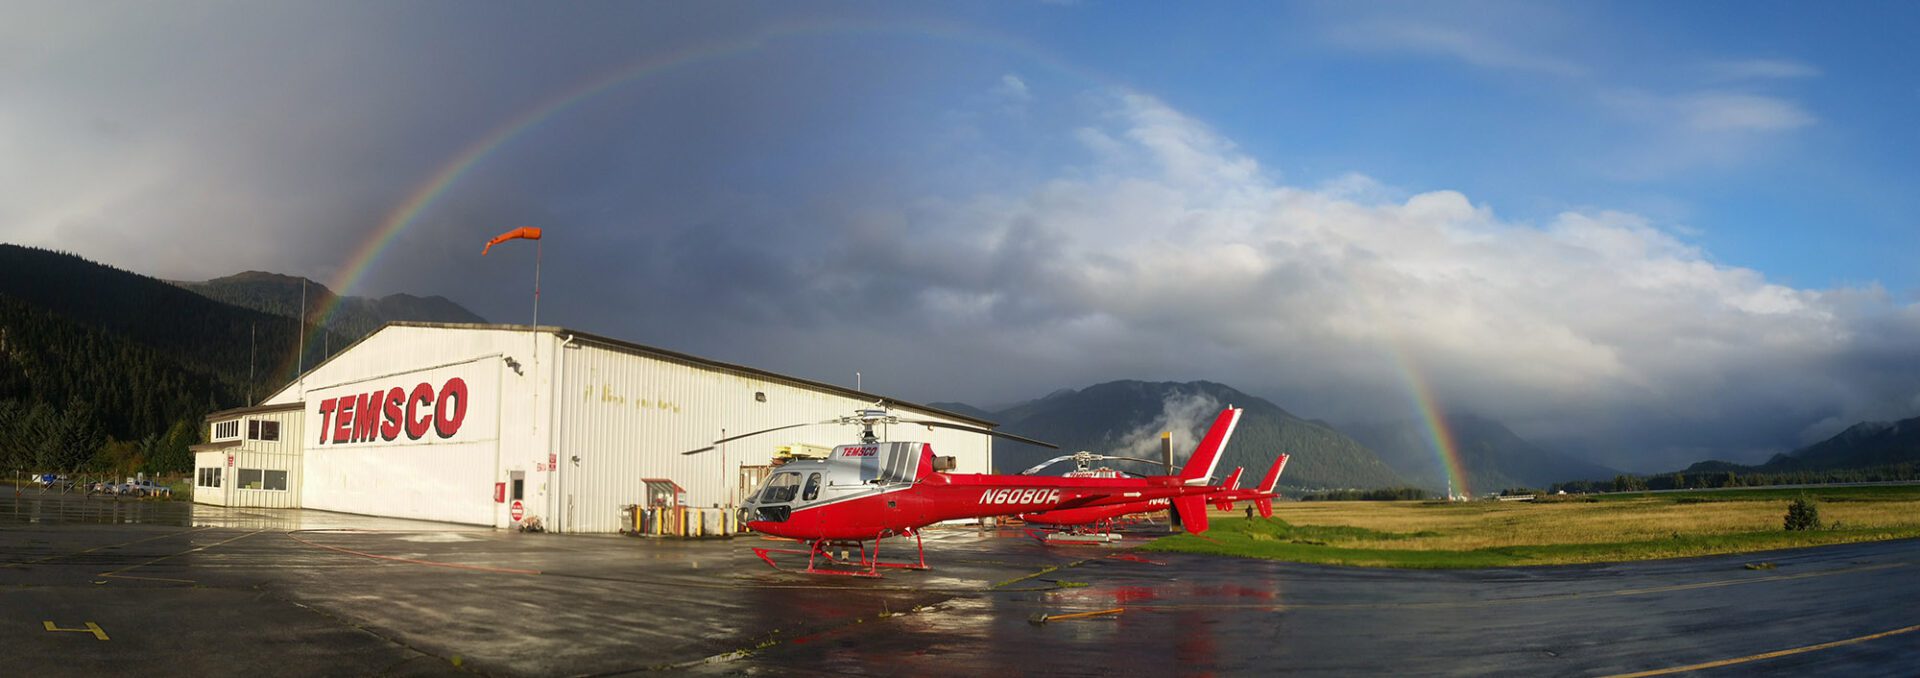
952, 380, 1405, 490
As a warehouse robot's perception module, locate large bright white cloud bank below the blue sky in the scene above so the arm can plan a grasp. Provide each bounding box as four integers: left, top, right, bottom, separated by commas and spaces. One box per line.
817, 92, 1920, 467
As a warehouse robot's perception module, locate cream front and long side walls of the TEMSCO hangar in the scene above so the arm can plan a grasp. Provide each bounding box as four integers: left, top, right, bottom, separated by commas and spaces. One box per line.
247, 325, 993, 532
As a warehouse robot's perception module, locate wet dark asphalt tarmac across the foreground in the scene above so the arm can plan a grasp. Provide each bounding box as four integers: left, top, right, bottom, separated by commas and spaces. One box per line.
0, 490, 1920, 676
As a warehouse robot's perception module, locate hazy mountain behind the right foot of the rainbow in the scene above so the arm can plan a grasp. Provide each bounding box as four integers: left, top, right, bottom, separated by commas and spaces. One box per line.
1340, 415, 1619, 494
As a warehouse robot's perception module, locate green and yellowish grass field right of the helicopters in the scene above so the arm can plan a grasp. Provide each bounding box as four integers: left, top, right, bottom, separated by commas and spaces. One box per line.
1144, 486, 1920, 569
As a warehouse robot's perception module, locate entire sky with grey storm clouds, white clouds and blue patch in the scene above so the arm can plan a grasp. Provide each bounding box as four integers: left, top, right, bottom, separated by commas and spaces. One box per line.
0, 2, 1920, 471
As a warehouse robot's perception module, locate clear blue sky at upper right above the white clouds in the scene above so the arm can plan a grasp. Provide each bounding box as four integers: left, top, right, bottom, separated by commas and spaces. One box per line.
975, 2, 1920, 298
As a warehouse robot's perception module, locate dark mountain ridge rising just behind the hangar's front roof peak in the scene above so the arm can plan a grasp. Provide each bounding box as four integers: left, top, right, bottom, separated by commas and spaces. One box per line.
173, 271, 486, 344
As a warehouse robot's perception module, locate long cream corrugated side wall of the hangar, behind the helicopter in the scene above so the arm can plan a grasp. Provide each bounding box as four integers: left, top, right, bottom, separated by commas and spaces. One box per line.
557, 344, 991, 532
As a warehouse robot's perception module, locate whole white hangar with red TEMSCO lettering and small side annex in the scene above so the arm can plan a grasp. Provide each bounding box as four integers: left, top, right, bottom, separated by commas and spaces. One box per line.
194, 323, 993, 532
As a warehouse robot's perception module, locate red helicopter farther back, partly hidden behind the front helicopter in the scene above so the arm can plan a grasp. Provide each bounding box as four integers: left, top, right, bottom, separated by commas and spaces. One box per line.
1020, 451, 1286, 544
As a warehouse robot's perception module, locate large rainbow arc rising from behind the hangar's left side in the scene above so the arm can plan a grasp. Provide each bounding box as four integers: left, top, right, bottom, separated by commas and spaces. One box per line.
280, 21, 1102, 376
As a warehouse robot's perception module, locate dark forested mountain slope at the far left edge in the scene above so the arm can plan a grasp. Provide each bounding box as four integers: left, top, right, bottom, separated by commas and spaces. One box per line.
0, 244, 314, 474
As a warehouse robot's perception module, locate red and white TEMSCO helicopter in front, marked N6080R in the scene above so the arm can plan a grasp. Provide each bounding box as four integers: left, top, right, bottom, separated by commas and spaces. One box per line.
687, 407, 1240, 576
